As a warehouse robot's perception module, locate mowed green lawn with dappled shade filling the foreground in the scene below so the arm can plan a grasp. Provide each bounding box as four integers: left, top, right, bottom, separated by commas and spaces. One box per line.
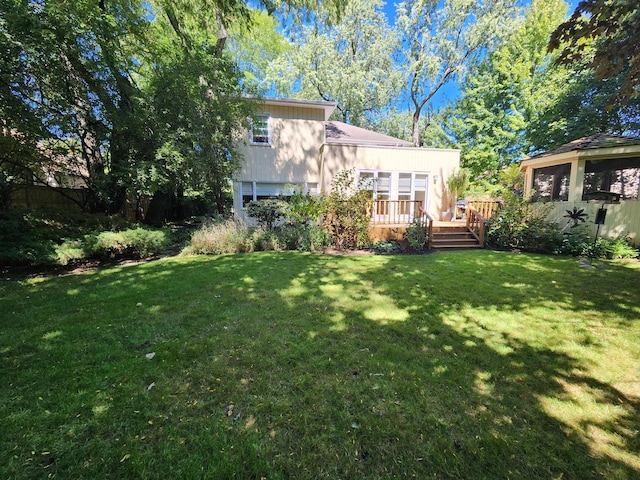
0, 251, 640, 479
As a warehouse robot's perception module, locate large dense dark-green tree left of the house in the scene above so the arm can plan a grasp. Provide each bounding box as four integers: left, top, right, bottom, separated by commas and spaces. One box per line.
0, 0, 341, 223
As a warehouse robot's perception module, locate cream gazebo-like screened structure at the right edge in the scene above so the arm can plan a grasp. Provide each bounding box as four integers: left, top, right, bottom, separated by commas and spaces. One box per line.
520, 134, 640, 247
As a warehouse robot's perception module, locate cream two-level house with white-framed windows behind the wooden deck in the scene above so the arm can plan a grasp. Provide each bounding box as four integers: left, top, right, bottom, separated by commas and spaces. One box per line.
233, 99, 460, 231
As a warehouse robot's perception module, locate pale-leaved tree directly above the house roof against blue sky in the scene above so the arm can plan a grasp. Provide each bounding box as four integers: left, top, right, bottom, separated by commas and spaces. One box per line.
269, 0, 400, 126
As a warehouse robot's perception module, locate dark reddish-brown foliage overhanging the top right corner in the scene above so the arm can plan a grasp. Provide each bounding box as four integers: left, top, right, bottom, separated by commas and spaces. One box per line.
548, 0, 640, 103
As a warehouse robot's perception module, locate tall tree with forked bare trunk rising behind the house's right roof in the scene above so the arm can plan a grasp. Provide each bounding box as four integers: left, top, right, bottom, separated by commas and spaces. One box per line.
396, 0, 515, 146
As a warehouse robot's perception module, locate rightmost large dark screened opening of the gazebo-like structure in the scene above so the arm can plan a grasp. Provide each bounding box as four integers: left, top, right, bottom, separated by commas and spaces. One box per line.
582, 158, 640, 200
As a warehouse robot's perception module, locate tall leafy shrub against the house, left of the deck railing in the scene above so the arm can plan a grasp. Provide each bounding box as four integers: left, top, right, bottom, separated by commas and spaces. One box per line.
322, 169, 371, 250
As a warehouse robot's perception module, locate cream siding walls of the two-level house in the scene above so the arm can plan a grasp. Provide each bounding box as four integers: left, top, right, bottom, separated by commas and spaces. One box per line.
233, 101, 460, 223
